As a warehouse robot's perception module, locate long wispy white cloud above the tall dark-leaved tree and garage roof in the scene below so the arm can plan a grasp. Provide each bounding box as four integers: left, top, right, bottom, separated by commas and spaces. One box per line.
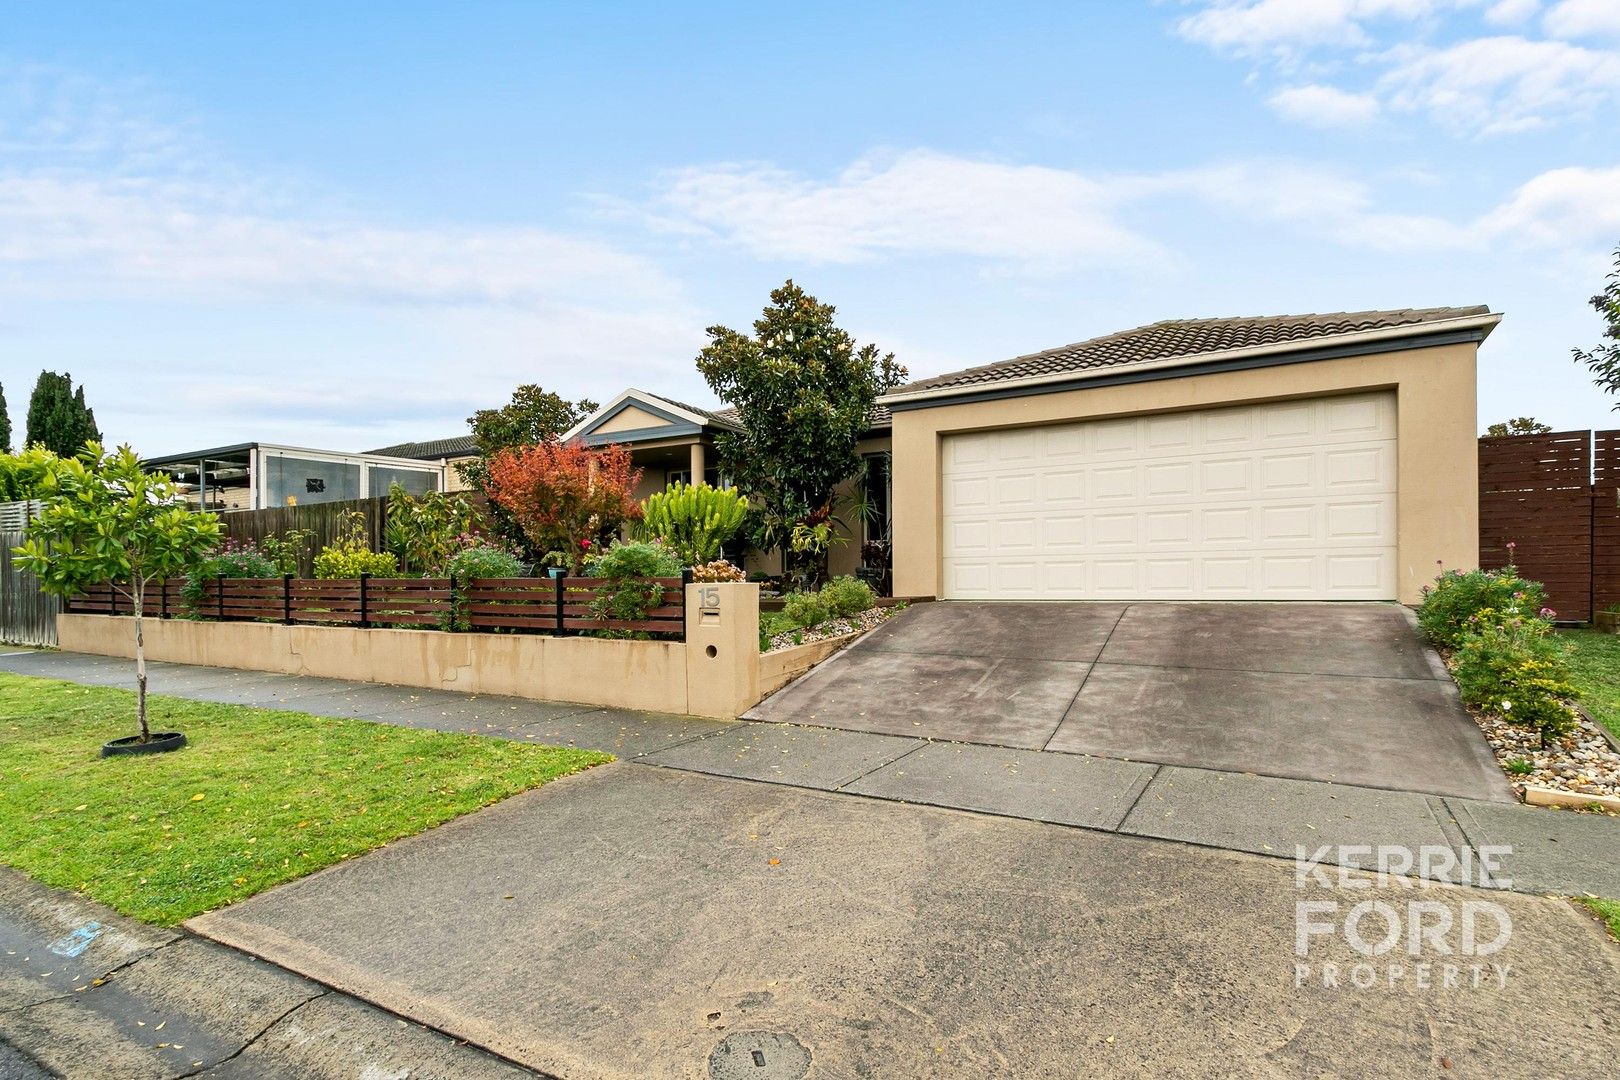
646, 151, 1158, 266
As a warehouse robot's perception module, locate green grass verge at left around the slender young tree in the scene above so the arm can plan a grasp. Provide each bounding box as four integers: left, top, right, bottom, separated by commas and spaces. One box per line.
0, 674, 612, 926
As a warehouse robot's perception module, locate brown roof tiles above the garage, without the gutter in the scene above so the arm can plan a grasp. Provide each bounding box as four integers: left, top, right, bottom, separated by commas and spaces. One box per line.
894, 306, 1490, 393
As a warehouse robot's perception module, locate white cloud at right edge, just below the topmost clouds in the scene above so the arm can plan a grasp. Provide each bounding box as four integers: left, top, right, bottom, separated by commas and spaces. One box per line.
1379, 37, 1620, 134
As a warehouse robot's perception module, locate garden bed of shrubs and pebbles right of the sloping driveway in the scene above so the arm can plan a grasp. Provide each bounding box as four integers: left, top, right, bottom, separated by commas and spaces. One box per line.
1418, 565, 1620, 806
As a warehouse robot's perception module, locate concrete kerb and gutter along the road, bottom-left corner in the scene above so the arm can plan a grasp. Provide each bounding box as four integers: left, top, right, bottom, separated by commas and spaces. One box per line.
0, 870, 536, 1080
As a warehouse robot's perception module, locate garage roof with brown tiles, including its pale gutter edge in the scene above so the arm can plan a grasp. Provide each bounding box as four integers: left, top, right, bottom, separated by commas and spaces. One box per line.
883, 304, 1500, 405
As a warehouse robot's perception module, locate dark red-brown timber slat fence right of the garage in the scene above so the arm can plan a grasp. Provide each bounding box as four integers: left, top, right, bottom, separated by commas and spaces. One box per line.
1479, 431, 1620, 622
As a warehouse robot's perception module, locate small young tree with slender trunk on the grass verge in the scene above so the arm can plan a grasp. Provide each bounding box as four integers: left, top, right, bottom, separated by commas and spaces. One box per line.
15, 442, 220, 743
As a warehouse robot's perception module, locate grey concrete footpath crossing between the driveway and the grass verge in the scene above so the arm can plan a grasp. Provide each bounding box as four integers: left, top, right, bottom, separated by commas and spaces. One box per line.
0, 651, 1620, 897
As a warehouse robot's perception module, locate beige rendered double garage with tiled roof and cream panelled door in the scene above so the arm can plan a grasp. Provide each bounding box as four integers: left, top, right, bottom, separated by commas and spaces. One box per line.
883, 308, 1502, 602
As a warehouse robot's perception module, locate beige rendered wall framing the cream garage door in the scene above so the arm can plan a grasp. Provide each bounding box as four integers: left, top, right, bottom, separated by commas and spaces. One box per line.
893, 343, 1479, 604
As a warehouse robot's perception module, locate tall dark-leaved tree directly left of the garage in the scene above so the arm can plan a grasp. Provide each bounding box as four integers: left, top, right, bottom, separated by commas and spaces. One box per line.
697, 280, 906, 582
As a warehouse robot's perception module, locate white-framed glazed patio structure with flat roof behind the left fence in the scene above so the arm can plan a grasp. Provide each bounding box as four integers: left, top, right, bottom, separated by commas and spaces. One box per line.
146, 442, 449, 510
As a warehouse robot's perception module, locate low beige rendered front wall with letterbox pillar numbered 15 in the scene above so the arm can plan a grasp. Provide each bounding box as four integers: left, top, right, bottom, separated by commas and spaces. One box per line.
57, 583, 760, 717
